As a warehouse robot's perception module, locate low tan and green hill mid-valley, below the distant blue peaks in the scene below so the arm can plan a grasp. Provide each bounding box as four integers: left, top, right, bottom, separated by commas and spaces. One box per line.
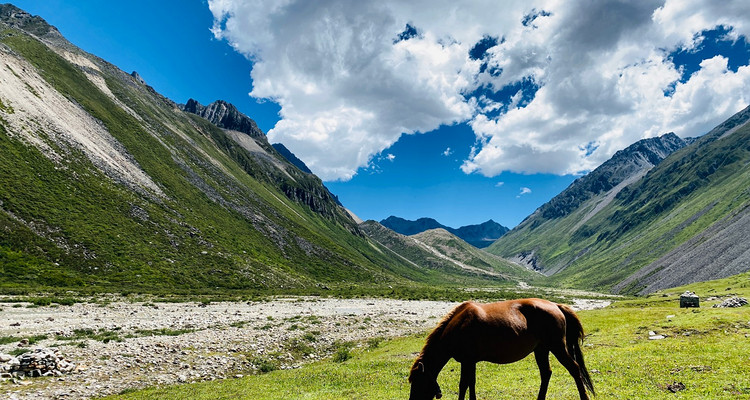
360, 220, 538, 282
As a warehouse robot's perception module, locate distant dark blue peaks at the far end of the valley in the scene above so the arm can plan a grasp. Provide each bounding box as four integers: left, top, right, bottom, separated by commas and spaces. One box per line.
380, 216, 509, 249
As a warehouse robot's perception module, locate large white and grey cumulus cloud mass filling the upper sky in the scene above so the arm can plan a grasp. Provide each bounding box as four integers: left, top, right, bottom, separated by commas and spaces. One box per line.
209, 0, 750, 180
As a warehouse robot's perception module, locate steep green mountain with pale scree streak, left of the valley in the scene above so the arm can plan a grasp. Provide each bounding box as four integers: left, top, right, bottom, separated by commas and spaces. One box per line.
0, 4, 506, 293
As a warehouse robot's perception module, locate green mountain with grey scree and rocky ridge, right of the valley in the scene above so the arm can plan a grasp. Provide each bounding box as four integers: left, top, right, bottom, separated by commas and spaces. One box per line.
487, 108, 750, 294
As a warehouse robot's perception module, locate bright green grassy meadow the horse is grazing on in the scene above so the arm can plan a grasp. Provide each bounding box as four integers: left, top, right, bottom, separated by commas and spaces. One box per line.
108, 274, 750, 400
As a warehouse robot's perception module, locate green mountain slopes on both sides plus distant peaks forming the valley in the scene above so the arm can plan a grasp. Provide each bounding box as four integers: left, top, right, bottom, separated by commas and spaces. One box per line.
0, 4, 750, 294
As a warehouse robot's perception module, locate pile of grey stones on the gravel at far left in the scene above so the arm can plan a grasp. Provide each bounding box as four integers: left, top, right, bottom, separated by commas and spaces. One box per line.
0, 348, 76, 378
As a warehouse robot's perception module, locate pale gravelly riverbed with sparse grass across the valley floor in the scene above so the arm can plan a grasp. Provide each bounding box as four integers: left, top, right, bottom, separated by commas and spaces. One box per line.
0, 296, 609, 400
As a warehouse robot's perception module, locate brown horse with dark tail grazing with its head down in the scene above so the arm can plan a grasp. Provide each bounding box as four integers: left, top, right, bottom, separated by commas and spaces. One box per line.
409, 299, 594, 400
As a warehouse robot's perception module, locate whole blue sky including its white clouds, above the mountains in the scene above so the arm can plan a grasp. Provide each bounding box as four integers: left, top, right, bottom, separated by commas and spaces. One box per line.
14, 0, 750, 227
